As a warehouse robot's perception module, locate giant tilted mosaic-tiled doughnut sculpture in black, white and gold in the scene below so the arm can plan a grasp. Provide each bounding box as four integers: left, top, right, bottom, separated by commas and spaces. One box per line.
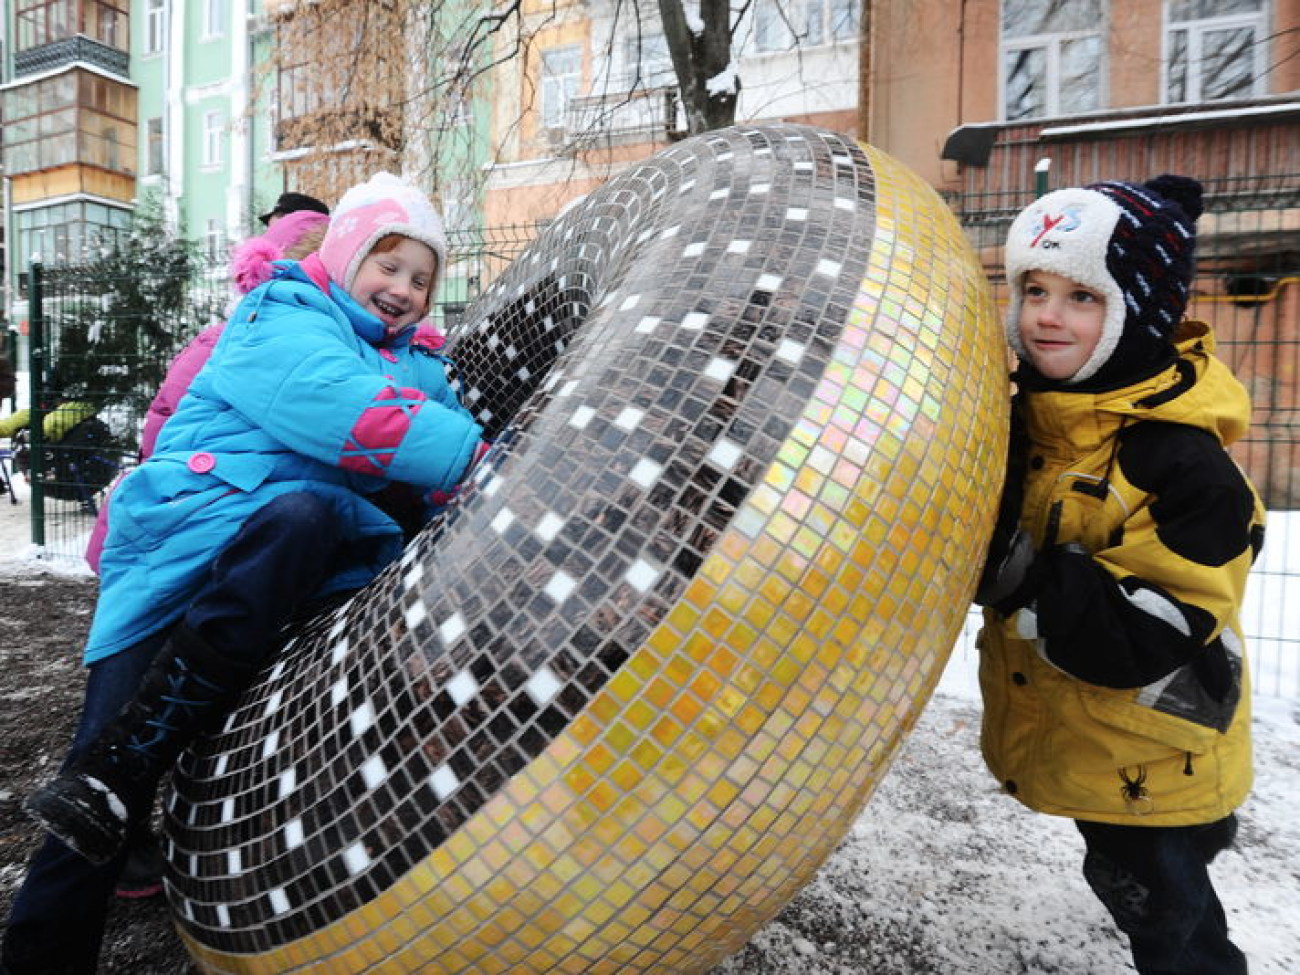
165, 125, 1006, 975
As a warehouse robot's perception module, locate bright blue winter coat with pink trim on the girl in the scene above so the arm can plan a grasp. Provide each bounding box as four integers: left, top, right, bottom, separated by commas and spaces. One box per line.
85, 263, 482, 664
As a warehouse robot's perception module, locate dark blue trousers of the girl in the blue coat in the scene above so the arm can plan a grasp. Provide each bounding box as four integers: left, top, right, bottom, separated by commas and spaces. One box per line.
3, 493, 339, 975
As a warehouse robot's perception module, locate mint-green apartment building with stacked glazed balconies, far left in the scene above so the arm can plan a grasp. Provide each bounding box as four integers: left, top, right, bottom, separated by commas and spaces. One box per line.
0, 0, 281, 351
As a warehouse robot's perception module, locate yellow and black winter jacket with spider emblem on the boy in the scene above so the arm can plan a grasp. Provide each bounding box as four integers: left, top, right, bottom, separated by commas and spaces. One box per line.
979, 322, 1264, 826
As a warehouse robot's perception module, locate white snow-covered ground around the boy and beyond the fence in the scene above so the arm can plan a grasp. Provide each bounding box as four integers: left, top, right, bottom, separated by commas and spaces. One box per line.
0, 470, 1300, 975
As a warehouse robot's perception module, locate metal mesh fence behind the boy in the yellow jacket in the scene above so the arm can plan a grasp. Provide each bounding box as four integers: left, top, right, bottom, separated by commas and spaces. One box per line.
949, 173, 1300, 698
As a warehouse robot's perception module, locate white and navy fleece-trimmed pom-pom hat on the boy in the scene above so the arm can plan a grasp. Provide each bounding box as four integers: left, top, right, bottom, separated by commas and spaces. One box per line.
1006, 176, 1203, 385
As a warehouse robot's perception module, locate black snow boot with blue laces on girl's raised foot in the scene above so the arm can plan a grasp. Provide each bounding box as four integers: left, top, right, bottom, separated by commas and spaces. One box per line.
26, 634, 256, 863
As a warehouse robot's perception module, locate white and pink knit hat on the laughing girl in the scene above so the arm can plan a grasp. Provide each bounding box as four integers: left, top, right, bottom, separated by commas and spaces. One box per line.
319, 173, 447, 295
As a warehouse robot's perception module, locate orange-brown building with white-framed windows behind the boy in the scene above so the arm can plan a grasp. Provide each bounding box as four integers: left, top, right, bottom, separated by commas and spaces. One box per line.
863, 0, 1300, 507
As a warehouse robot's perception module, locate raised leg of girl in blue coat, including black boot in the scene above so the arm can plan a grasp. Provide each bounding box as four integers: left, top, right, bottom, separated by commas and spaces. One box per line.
27, 493, 351, 863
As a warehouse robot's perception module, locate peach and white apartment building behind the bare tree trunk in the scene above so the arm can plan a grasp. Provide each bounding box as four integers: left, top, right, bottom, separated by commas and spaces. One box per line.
484, 0, 862, 226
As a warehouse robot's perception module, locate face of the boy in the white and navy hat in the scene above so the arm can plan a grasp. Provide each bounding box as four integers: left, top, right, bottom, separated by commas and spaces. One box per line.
1019, 270, 1106, 380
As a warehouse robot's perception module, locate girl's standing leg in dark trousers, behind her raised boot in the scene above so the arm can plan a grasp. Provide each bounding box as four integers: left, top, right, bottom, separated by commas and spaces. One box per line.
3, 632, 166, 975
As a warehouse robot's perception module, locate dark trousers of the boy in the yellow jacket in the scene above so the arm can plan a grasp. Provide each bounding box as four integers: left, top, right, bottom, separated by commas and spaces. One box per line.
1076, 815, 1245, 975
